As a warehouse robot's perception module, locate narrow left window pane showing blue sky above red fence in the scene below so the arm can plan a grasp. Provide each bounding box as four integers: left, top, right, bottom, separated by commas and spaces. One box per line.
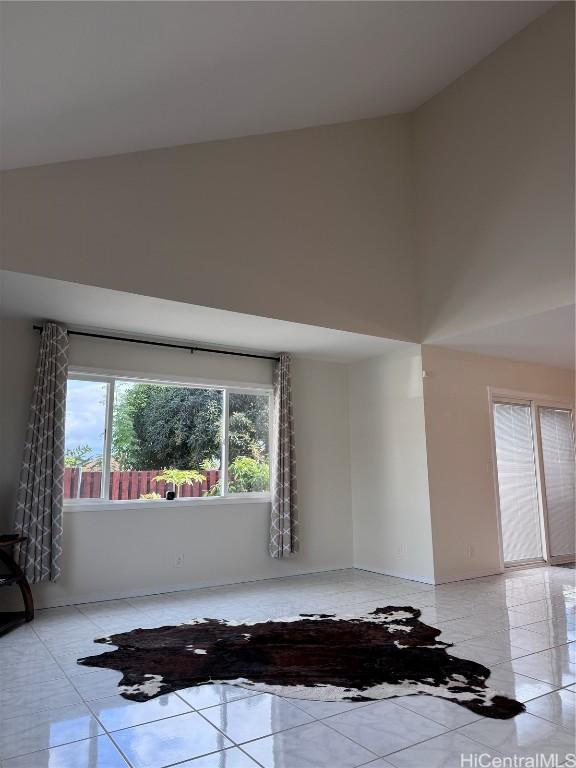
64, 379, 108, 499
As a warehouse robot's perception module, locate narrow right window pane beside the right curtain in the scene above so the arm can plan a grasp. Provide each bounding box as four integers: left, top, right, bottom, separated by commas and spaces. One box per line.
228, 393, 270, 493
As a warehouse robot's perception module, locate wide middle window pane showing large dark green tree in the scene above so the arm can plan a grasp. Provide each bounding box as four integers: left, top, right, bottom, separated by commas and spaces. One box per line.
108, 381, 223, 500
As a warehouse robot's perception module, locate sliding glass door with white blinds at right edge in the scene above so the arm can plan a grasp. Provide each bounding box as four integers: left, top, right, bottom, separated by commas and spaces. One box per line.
492, 398, 576, 566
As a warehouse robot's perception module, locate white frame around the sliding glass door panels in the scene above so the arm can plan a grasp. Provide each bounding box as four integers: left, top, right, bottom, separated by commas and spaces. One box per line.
488, 386, 574, 573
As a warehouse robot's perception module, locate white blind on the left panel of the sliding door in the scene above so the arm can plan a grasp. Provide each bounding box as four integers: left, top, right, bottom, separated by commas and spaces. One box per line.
494, 403, 543, 564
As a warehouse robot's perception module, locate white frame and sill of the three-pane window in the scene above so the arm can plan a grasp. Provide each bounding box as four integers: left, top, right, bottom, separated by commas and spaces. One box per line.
64, 366, 273, 510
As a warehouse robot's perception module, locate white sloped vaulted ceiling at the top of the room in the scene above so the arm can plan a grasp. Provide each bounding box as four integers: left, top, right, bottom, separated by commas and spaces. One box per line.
0, 0, 553, 168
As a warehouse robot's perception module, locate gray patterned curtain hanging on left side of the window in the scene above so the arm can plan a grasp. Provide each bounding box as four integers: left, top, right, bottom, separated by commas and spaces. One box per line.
15, 323, 68, 583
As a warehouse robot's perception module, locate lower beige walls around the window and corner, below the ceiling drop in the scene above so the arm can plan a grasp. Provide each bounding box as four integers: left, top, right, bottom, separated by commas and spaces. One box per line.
0, 328, 574, 605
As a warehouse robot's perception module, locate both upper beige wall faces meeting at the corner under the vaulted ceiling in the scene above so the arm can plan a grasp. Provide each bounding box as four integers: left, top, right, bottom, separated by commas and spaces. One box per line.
0, 2, 574, 348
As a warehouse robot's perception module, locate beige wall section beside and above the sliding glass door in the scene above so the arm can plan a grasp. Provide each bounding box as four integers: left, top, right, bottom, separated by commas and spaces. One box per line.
422, 345, 574, 582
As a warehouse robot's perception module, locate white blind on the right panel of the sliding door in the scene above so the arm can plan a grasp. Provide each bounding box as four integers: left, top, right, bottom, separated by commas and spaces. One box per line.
539, 407, 576, 557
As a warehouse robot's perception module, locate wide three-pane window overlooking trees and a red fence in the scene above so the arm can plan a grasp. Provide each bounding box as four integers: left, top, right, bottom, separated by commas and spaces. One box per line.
64, 373, 271, 501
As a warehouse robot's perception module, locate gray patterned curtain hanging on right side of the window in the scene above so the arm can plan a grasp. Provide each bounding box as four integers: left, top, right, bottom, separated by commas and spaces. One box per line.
270, 352, 298, 557
